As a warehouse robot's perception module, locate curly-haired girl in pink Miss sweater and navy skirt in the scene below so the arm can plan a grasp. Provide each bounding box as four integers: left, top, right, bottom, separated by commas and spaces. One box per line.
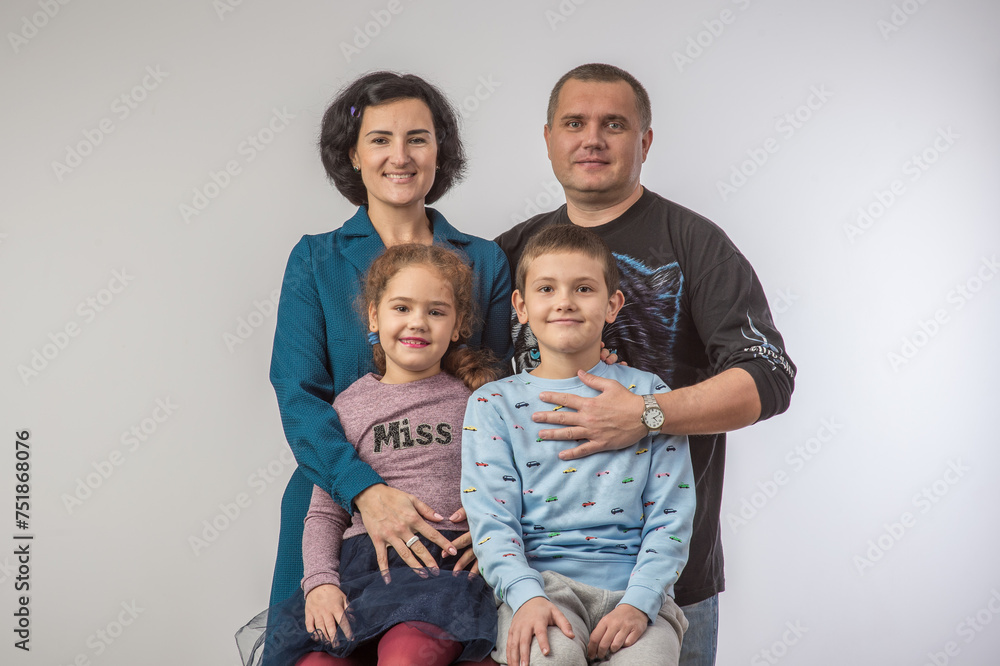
237, 244, 496, 666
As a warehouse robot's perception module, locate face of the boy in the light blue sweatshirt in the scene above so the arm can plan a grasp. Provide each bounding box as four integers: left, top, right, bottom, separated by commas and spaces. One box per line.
512, 252, 625, 369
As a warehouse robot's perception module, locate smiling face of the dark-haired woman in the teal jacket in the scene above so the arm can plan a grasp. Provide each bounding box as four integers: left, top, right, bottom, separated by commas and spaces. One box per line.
350, 99, 437, 217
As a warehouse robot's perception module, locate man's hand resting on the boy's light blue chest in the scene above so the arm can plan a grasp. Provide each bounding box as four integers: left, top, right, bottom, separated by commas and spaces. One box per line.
533, 370, 648, 460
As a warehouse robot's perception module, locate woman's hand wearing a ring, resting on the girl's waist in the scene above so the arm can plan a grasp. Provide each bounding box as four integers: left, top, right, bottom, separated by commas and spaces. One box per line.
354, 484, 458, 583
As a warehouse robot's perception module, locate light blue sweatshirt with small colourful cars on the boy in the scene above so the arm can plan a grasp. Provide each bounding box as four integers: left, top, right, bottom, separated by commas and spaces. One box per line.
462, 362, 695, 621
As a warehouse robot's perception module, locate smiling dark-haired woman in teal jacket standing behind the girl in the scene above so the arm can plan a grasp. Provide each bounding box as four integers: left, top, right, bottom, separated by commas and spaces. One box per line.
271, 72, 510, 605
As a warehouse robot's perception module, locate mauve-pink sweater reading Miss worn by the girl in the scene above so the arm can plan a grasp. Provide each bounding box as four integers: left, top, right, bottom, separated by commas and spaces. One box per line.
302, 372, 470, 595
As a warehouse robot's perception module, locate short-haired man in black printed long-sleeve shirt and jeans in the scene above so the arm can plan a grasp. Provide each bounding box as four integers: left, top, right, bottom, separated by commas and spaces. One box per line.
496, 64, 795, 666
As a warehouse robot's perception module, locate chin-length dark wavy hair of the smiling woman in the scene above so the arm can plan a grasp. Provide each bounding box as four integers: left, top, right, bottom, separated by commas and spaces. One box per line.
319, 72, 465, 206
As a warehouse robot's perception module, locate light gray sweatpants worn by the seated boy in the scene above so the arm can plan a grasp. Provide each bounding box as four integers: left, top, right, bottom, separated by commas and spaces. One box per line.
493, 571, 687, 666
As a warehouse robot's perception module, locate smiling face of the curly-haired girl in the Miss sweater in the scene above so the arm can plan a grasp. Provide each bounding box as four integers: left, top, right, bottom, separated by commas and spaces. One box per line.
368, 264, 459, 384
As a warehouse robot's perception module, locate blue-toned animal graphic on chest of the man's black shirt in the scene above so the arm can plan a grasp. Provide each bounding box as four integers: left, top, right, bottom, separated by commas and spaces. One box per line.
511, 253, 684, 384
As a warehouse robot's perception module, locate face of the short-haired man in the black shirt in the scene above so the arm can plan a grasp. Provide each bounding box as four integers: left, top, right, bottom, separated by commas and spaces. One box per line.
545, 79, 653, 206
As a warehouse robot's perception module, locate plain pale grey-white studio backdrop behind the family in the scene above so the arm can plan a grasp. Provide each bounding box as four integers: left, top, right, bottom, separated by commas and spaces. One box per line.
0, 0, 1000, 666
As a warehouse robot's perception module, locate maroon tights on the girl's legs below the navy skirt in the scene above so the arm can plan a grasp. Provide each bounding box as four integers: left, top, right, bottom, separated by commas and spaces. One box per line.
296, 622, 496, 666
